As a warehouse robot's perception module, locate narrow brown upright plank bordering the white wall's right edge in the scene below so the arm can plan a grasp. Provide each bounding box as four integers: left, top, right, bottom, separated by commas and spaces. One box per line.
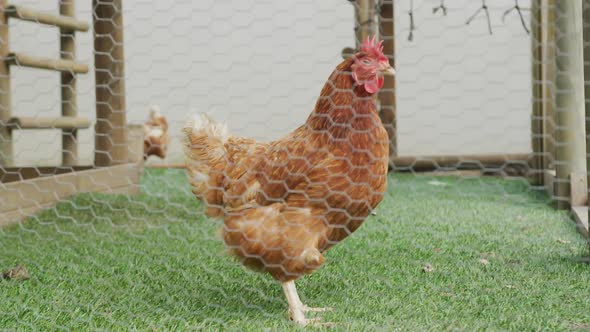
529, 0, 544, 185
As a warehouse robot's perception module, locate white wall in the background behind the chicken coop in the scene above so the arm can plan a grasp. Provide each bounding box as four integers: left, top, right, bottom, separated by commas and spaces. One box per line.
6, 0, 531, 165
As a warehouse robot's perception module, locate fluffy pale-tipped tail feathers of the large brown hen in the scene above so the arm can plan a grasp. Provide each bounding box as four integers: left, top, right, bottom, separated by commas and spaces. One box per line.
182, 114, 229, 215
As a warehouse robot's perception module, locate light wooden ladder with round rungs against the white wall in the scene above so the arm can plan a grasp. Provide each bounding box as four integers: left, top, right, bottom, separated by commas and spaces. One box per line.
0, 0, 90, 166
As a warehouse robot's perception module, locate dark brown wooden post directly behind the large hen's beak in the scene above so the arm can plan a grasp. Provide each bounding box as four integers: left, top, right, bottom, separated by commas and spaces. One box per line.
379, 0, 397, 164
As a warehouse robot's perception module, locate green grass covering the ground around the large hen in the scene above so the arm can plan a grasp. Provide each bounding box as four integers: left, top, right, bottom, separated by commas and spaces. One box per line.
0, 170, 590, 331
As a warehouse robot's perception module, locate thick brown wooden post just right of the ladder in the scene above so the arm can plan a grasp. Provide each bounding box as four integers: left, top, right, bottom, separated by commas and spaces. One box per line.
92, 0, 128, 166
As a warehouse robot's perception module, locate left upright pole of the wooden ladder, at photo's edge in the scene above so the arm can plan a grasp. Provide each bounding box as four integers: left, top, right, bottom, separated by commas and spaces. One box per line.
0, 0, 13, 166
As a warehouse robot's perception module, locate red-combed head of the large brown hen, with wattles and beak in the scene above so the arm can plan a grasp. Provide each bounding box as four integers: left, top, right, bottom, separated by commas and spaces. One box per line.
351, 37, 395, 94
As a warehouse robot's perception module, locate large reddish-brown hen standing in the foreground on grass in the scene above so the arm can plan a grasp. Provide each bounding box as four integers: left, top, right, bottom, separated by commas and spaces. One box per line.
183, 39, 393, 325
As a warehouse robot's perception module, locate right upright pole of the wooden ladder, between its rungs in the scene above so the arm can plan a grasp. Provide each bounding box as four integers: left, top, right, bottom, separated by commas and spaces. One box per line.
59, 0, 78, 166
